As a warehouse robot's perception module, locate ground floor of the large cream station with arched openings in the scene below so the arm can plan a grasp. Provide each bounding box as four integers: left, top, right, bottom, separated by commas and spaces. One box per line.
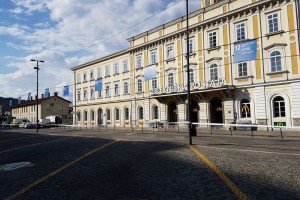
73, 82, 300, 127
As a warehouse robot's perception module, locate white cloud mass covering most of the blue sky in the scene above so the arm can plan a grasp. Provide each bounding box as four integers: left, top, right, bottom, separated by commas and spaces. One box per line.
0, 0, 199, 97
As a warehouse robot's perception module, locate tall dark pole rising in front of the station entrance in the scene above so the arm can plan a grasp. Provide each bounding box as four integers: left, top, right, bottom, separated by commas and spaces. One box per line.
185, 0, 192, 145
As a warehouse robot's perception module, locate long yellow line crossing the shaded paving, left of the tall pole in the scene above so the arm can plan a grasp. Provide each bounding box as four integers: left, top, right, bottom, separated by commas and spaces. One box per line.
5, 140, 119, 200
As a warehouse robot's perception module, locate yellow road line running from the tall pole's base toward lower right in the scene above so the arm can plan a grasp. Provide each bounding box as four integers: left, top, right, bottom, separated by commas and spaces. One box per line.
189, 145, 248, 200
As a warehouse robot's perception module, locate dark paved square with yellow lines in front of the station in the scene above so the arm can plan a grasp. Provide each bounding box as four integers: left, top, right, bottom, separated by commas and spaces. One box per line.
0, 129, 300, 200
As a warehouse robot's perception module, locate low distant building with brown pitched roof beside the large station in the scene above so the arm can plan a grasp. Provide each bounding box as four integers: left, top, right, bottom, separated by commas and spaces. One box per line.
12, 93, 73, 123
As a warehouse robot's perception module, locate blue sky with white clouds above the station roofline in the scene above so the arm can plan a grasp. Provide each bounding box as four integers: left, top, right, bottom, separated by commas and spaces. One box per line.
0, 0, 200, 100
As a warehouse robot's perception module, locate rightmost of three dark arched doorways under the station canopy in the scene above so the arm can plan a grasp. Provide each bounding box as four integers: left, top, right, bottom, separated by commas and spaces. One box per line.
210, 98, 223, 124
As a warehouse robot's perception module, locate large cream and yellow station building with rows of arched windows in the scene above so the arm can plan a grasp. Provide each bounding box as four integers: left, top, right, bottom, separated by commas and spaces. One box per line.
72, 0, 300, 127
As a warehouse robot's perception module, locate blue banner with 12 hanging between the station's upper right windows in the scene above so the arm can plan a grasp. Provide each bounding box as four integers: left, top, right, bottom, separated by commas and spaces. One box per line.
233, 40, 257, 63
